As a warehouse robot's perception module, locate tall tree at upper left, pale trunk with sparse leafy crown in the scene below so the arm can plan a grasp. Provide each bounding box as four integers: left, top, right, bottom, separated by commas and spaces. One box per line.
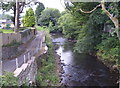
2, 0, 38, 32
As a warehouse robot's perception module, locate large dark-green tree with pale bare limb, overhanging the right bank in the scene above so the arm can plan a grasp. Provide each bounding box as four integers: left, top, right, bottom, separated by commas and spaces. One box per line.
63, 0, 120, 69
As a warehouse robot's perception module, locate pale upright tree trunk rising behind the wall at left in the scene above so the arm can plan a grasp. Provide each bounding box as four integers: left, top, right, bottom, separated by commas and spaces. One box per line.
14, 0, 19, 32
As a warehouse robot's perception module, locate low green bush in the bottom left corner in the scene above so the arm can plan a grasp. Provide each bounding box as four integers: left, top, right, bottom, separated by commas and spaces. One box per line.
0, 72, 18, 87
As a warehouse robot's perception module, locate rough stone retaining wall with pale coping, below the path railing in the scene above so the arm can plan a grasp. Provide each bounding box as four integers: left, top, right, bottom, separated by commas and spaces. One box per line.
14, 57, 37, 85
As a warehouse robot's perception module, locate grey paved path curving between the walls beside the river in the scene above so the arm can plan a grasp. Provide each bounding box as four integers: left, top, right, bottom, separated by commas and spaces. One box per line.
3, 32, 43, 72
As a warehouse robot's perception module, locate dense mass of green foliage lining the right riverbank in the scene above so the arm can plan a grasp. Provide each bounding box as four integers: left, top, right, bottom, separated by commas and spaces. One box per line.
58, 2, 120, 70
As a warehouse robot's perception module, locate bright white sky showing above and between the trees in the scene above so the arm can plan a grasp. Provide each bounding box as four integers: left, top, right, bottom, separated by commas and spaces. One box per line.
0, 0, 65, 15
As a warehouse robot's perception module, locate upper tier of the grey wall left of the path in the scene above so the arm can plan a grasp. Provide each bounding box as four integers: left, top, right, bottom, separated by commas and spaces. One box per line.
0, 29, 36, 46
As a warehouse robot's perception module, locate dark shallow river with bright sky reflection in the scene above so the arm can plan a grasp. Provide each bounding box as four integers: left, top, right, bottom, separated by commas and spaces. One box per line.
52, 34, 118, 88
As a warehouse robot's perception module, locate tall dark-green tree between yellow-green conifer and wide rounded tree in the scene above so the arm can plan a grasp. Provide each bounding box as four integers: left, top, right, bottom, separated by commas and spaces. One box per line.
35, 3, 45, 24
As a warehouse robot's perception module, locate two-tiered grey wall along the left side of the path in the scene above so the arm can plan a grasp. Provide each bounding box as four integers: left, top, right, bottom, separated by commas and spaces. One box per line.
0, 29, 36, 59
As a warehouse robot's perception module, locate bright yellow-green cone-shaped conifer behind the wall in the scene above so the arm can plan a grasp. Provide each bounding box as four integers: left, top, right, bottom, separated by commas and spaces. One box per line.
24, 8, 35, 27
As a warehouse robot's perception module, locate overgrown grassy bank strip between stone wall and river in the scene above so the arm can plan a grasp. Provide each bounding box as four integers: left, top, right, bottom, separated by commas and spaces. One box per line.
36, 32, 59, 86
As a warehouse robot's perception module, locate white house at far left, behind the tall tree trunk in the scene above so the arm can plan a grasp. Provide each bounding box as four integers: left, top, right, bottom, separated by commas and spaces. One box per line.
0, 19, 14, 29
